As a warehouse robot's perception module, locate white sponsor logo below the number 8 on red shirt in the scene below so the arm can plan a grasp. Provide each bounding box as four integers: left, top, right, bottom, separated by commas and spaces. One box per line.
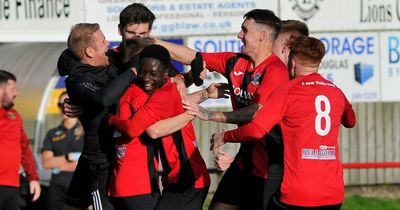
301, 145, 336, 160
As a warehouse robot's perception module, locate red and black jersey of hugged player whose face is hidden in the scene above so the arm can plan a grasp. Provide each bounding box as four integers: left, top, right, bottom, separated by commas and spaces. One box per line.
110, 84, 159, 197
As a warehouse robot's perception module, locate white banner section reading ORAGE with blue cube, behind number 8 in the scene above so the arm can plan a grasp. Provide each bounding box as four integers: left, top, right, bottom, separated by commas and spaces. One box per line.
312, 33, 381, 102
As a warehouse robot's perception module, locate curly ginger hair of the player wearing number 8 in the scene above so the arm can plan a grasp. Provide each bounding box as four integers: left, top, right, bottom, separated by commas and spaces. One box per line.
287, 35, 325, 66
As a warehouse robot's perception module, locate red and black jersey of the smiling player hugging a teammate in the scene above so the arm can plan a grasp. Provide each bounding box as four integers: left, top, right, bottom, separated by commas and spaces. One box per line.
109, 79, 210, 188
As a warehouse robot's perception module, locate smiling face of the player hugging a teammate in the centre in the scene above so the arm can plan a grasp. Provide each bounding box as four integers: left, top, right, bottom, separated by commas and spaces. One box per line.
138, 58, 168, 94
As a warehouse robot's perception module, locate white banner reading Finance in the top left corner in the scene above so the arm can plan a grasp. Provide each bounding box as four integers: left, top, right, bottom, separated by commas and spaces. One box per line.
0, 0, 84, 42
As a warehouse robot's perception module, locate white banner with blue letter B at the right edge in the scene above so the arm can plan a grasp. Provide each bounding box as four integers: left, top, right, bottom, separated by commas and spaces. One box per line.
381, 32, 400, 101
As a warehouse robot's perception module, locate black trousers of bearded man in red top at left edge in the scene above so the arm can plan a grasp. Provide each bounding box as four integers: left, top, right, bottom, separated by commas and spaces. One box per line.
0, 186, 19, 210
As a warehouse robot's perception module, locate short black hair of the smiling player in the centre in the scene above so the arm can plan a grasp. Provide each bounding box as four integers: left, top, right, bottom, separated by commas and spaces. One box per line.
139, 44, 171, 67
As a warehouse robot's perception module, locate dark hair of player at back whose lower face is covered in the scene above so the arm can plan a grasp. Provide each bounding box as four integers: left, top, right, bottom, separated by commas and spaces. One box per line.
118, 3, 156, 31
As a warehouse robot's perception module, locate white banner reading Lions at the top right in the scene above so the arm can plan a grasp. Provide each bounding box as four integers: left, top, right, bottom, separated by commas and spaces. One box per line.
280, 0, 400, 32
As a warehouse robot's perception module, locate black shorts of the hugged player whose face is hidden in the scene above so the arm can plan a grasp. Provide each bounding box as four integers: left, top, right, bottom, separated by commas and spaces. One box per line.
110, 192, 160, 210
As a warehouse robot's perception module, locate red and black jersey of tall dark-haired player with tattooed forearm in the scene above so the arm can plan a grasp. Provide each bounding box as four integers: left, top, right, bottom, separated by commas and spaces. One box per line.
202, 52, 289, 178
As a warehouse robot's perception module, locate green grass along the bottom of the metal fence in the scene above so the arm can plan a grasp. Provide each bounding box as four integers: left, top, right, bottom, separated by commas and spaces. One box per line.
203, 195, 400, 210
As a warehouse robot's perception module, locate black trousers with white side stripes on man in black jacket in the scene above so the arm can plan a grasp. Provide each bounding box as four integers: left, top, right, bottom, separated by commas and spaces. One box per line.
65, 156, 114, 210
